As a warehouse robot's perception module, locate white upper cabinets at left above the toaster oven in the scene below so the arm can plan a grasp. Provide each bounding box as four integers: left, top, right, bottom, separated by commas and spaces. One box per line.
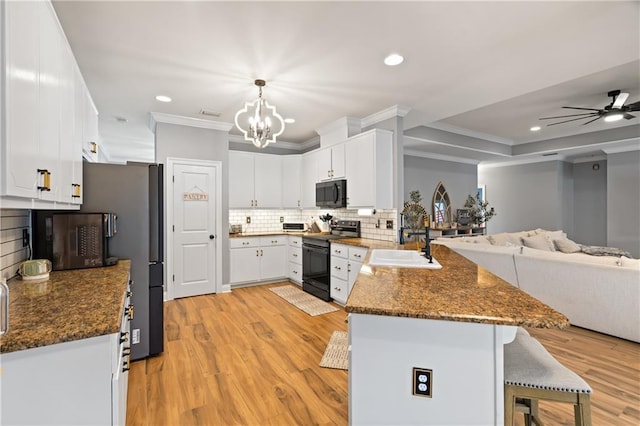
0, 1, 89, 209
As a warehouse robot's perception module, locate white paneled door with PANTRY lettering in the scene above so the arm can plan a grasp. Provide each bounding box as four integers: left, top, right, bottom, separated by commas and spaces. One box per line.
169, 160, 222, 297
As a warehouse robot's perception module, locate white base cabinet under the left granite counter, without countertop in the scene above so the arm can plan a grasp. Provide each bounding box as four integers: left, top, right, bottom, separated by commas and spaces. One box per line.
0, 286, 130, 426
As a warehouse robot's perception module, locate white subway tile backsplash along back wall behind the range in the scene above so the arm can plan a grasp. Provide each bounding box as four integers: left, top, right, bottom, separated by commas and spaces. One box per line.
229, 209, 398, 241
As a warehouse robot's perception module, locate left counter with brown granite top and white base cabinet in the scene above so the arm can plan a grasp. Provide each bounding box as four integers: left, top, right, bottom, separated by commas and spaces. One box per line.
0, 260, 135, 425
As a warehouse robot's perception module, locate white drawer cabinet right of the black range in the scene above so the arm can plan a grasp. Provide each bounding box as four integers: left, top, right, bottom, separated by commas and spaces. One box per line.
330, 244, 367, 305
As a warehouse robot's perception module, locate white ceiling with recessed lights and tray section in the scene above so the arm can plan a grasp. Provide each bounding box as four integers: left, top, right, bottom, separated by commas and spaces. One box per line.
53, 0, 640, 162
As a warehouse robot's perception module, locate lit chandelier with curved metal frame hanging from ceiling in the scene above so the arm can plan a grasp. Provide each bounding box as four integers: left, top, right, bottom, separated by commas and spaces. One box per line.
235, 80, 284, 148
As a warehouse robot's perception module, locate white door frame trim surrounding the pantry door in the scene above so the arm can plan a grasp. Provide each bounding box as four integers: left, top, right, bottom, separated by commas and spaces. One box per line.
164, 157, 225, 300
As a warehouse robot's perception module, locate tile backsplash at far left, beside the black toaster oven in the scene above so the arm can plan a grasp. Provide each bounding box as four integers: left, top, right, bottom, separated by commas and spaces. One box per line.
0, 209, 31, 278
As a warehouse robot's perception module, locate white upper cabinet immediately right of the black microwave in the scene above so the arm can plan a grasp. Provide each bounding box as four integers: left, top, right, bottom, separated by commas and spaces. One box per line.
345, 129, 393, 209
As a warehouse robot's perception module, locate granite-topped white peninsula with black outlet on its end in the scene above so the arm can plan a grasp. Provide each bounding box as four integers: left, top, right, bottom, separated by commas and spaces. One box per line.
340, 240, 569, 425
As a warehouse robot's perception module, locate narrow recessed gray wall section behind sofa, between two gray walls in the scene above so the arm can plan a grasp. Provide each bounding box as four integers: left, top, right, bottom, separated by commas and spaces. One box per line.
573, 160, 607, 246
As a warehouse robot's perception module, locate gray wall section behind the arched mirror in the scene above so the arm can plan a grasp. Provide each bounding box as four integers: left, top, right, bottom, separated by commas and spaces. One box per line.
398, 155, 476, 221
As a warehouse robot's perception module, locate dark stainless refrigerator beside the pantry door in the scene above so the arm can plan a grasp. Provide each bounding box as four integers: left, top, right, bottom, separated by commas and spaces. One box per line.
80, 163, 164, 360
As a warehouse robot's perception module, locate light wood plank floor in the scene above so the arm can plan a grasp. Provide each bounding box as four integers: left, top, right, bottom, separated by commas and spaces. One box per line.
127, 283, 640, 426
